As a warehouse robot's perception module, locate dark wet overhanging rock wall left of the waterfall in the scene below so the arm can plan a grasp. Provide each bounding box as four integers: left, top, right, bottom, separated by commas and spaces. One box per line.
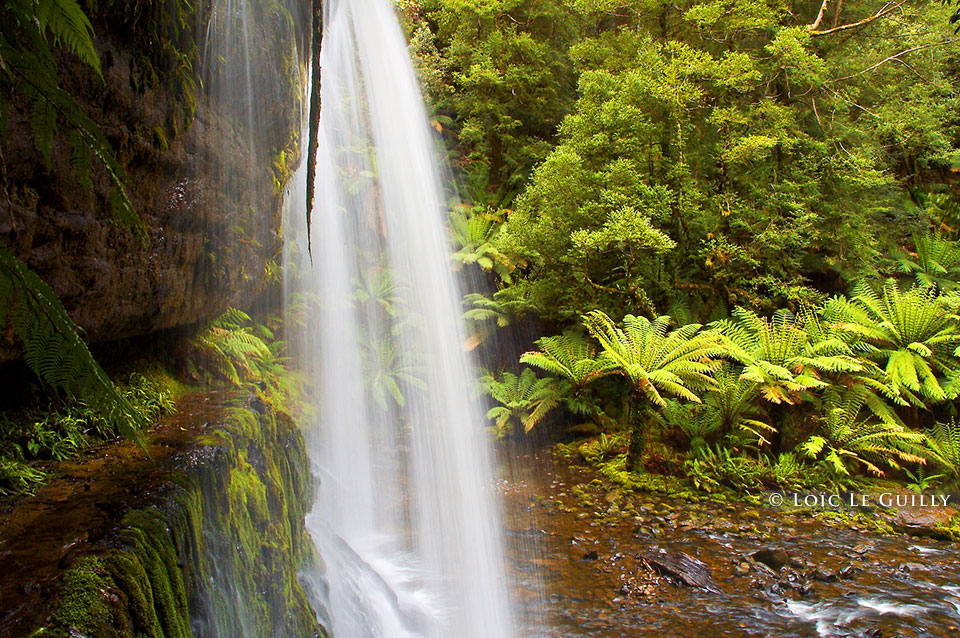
0, 0, 300, 361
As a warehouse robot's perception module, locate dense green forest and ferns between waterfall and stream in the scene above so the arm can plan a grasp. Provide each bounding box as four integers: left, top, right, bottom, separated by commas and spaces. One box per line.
401, 0, 960, 490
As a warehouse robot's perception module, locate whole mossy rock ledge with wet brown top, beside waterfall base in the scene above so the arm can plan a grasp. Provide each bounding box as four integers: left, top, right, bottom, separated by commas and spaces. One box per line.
0, 392, 326, 638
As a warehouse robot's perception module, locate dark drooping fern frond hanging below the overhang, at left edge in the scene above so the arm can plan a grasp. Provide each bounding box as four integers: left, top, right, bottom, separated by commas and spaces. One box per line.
0, 247, 146, 440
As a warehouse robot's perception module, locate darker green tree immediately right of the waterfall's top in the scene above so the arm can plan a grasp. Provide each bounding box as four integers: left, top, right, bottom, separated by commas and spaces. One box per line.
421, 0, 581, 204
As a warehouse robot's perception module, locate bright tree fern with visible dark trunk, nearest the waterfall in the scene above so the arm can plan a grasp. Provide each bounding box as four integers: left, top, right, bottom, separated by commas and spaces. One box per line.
583, 310, 725, 468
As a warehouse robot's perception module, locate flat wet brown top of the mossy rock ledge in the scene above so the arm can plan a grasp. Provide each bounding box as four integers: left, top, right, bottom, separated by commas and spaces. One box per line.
0, 393, 221, 636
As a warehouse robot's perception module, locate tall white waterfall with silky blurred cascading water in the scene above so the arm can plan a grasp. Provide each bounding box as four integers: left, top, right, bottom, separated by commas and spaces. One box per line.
291, 0, 513, 638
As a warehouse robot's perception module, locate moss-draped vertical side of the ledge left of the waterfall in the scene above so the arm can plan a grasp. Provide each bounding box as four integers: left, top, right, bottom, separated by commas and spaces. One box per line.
34, 403, 326, 638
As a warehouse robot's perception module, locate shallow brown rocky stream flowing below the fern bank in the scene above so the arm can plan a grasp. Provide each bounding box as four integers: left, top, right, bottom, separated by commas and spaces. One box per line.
501, 454, 960, 638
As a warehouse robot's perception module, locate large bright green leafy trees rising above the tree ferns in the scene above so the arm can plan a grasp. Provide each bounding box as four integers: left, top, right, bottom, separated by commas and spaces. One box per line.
497, 0, 960, 321
